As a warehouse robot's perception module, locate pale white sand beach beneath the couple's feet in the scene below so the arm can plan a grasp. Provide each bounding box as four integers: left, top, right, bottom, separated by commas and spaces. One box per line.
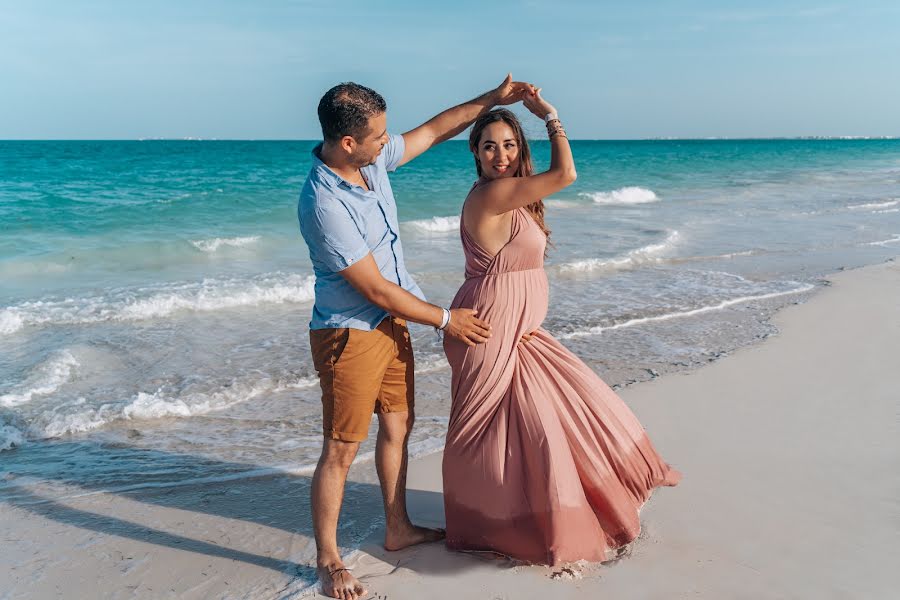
0, 261, 900, 600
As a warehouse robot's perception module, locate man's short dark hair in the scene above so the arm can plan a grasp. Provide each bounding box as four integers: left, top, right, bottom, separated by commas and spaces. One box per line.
319, 82, 387, 141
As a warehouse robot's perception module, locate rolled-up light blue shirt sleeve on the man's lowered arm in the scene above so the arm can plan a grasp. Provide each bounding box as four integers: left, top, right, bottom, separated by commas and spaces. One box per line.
304, 200, 370, 272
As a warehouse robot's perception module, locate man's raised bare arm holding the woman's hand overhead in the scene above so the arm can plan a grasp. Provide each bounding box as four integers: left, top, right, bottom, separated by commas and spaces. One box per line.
398, 73, 534, 166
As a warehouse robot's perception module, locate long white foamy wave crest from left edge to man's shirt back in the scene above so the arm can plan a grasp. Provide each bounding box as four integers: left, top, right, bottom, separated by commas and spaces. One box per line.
0, 272, 315, 334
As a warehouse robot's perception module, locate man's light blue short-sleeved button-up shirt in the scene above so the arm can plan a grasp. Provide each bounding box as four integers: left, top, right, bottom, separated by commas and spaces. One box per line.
297, 135, 425, 331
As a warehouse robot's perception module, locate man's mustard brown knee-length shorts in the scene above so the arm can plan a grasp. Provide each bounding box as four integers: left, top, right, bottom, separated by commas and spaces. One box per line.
309, 317, 415, 442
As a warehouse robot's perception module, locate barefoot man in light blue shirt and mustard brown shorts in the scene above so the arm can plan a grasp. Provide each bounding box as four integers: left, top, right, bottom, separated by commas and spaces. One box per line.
298, 76, 534, 599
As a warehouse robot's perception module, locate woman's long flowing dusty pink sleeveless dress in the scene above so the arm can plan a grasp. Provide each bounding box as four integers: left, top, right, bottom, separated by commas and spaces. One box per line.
443, 208, 681, 565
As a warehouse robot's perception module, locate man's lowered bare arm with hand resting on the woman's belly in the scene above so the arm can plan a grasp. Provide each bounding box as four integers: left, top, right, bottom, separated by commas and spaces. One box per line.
340, 253, 491, 346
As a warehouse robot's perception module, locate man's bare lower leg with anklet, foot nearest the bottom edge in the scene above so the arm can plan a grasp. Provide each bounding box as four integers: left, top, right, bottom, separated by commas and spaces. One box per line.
312, 439, 366, 600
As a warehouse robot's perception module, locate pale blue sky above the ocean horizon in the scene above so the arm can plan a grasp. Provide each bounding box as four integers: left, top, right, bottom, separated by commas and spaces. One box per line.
0, 0, 900, 139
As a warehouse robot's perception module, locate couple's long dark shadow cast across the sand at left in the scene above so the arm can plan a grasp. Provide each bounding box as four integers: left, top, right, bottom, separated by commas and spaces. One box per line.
0, 441, 461, 582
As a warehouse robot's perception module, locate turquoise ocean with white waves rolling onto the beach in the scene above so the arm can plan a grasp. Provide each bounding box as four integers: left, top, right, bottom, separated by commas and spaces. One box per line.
0, 139, 900, 564
